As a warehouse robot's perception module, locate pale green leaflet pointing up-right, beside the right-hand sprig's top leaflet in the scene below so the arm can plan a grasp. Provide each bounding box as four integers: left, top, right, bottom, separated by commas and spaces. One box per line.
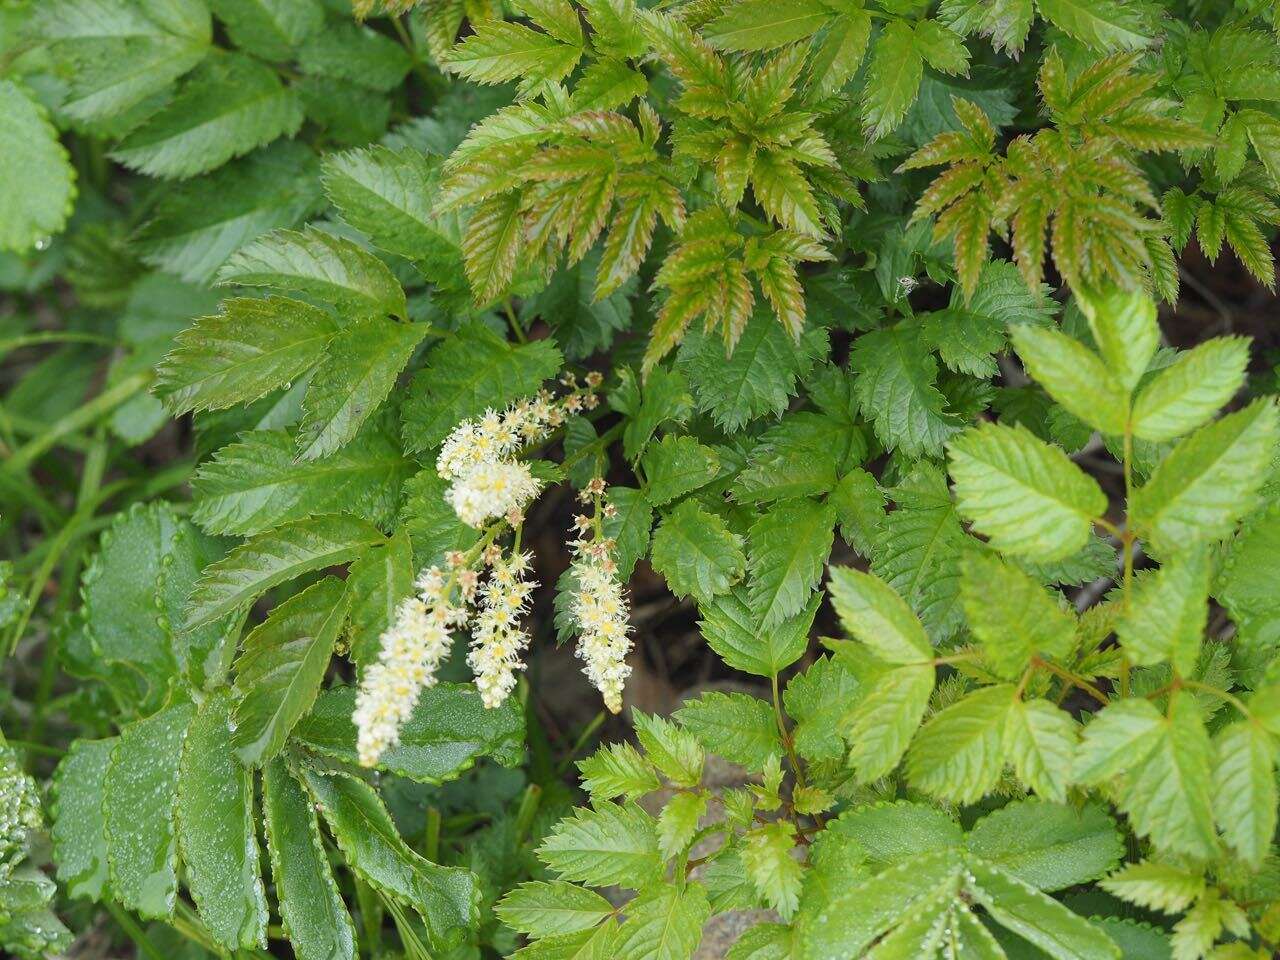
1133, 337, 1249, 443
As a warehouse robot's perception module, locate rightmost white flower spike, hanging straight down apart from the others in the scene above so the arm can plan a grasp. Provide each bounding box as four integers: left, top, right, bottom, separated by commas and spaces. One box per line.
570, 477, 631, 713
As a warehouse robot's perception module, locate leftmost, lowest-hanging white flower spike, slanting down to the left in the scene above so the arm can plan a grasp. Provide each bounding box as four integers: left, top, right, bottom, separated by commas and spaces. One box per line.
352, 567, 467, 767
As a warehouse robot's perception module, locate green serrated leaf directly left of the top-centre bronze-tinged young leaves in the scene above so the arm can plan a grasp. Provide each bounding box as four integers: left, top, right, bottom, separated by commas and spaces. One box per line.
324, 146, 462, 268
